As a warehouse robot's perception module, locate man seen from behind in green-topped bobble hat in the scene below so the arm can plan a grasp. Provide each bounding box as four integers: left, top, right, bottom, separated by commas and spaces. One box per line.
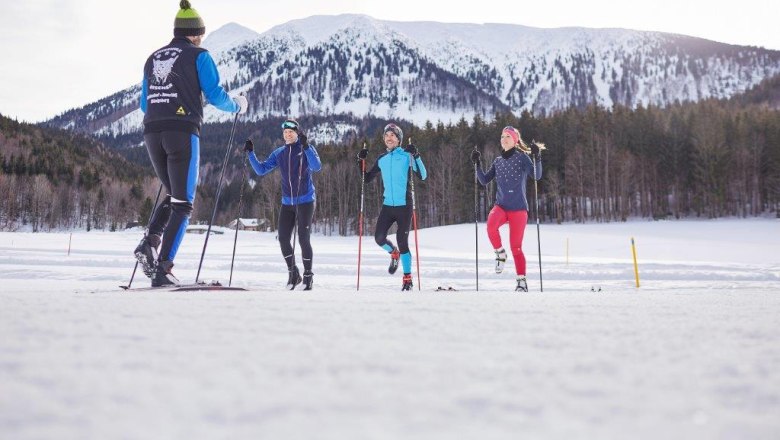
135, 0, 247, 287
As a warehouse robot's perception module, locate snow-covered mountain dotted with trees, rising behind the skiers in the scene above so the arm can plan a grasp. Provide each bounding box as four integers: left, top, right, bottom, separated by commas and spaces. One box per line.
50, 14, 780, 141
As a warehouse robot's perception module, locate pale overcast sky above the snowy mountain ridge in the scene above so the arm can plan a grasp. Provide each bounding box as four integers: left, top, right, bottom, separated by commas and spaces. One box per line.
0, 0, 780, 122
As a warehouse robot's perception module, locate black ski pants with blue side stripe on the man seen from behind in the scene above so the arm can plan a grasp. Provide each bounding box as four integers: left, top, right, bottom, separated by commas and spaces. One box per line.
144, 131, 200, 261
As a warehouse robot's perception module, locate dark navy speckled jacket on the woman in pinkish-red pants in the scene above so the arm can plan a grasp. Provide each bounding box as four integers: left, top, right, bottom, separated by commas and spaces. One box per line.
477, 148, 542, 211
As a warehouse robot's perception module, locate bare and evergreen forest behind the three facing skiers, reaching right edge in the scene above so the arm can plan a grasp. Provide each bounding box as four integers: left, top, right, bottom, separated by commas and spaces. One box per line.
213, 100, 780, 235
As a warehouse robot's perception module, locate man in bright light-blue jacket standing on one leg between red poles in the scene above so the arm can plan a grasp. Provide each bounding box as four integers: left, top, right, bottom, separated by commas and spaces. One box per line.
358, 123, 428, 290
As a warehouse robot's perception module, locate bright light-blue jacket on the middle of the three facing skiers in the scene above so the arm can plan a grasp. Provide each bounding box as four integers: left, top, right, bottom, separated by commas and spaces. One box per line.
365, 147, 428, 206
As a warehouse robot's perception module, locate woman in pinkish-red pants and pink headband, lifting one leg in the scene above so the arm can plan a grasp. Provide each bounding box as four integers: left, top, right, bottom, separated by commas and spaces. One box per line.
471, 126, 544, 292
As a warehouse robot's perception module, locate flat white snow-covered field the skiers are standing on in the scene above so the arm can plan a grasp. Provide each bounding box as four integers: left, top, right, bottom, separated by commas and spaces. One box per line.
0, 219, 780, 440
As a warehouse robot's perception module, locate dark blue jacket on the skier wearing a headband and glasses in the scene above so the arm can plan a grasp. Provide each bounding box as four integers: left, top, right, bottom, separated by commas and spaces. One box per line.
249, 141, 322, 205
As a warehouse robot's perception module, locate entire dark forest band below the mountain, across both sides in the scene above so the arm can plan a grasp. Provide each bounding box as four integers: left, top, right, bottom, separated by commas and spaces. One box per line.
0, 94, 780, 235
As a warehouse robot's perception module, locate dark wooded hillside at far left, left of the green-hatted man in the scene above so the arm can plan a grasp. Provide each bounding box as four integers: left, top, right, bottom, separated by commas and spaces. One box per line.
0, 115, 155, 232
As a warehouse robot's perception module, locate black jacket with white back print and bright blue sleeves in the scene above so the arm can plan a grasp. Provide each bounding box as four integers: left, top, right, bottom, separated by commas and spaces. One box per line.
141, 37, 239, 134
